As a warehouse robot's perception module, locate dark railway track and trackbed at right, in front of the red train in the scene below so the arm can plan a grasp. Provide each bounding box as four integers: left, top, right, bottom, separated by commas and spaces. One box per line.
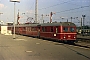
44, 38, 90, 49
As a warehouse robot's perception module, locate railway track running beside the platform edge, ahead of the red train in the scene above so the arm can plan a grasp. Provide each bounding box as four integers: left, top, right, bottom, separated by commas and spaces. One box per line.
40, 39, 90, 49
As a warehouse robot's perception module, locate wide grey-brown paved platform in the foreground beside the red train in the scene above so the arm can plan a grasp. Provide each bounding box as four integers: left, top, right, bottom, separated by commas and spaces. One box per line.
0, 34, 90, 60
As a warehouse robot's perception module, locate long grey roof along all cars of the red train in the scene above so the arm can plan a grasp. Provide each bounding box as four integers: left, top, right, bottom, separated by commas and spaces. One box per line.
7, 22, 76, 27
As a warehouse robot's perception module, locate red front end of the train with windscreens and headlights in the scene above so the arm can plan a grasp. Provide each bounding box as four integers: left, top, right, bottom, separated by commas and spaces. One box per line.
60, 22, 77, 42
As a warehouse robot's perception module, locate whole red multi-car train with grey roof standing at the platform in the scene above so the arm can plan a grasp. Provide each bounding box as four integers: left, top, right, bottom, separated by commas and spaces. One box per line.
8, 22, 77, 42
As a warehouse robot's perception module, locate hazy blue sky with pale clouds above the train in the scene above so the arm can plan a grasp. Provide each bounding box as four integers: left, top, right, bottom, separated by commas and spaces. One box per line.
0, 0, 90, 25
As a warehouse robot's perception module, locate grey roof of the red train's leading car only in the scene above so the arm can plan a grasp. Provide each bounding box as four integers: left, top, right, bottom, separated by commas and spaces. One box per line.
39, 22, 76, 26
